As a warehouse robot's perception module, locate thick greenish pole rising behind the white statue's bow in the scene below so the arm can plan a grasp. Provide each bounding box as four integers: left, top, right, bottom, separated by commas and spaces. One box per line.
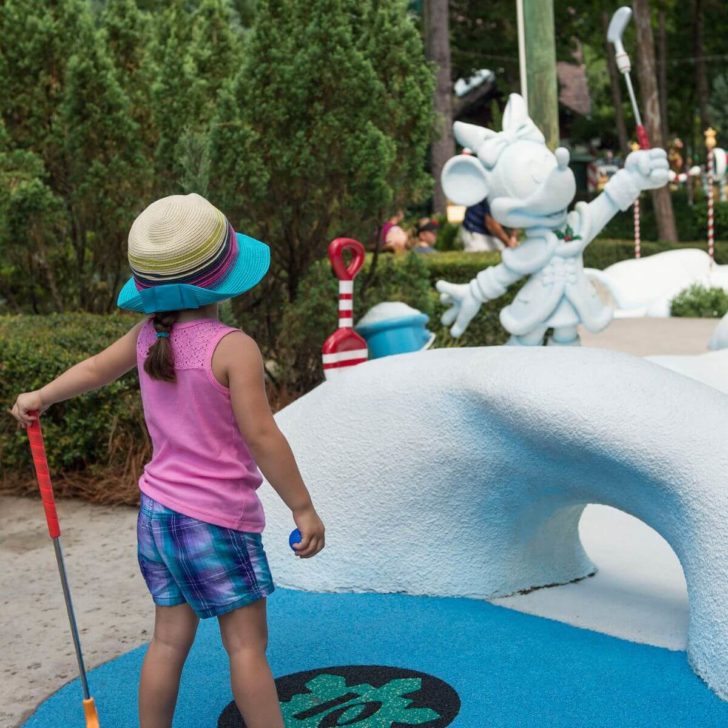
519, 0, 559, 149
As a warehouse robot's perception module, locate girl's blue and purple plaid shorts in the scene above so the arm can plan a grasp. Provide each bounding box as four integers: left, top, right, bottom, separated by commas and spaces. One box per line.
137, 493, 274, 617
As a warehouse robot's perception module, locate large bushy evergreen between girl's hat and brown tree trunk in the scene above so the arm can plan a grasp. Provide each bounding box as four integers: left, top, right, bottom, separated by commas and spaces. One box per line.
212, 0, 432, 308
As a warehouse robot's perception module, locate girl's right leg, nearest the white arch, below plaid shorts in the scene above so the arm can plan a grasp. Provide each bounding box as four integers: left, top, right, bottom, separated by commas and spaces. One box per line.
219, 599, 283, 728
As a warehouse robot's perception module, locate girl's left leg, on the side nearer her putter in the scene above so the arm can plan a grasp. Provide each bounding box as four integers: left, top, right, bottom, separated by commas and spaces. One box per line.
139, 604, 199, 728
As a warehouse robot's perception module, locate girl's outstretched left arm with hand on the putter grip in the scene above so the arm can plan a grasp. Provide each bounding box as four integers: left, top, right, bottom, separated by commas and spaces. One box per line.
10, 321, 144, 427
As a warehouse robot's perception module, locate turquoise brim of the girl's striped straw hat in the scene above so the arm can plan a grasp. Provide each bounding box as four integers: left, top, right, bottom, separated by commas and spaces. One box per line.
116, 233, 270, 313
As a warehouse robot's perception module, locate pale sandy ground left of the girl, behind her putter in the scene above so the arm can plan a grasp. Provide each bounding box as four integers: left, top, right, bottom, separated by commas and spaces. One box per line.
0, 497, 145, 728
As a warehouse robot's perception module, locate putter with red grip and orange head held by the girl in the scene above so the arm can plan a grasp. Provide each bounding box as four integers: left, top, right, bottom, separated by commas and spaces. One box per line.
28, 412, 99, 728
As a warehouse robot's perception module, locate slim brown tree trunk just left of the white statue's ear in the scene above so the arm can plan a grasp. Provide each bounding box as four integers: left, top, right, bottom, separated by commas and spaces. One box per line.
424, 0, 455, 214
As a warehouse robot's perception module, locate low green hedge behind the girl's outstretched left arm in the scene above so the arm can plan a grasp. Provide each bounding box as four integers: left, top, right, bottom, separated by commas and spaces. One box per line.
0, 314, 148, 502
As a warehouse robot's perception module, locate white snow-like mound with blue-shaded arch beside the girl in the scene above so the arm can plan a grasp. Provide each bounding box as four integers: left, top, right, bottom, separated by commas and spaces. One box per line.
261, 347, 728, 698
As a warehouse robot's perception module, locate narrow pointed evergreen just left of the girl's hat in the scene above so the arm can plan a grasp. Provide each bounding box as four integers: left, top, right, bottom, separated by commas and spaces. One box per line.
56, 6, 149, 310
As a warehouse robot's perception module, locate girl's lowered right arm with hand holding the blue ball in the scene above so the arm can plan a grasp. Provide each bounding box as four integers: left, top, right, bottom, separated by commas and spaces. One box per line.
213, 332, 324, 558
